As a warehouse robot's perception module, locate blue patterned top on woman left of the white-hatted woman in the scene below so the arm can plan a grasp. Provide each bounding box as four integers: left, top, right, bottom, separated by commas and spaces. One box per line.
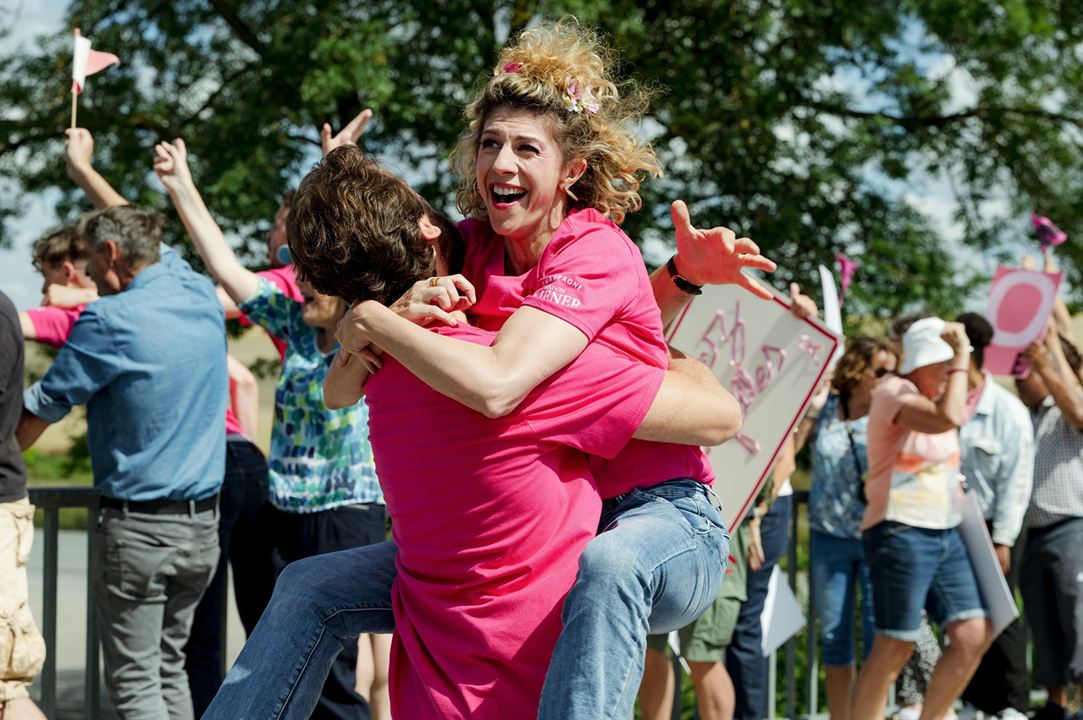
809, 393, 869, 539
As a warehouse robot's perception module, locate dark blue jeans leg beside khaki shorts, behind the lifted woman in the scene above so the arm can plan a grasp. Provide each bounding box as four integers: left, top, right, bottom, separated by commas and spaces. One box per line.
726, 495, 793, 720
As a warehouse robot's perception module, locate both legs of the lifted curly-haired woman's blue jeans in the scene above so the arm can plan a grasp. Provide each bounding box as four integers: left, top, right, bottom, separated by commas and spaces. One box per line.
204, 481, 729, 720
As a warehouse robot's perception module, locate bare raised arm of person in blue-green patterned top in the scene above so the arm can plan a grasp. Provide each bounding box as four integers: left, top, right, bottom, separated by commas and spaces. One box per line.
154, 140, 259, 303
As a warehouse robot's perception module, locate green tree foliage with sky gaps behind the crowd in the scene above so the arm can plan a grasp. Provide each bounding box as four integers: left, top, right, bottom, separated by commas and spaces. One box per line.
0, 0, 1083, 317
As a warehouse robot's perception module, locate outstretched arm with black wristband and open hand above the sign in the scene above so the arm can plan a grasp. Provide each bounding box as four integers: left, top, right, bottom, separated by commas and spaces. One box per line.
651, 200, 775, 325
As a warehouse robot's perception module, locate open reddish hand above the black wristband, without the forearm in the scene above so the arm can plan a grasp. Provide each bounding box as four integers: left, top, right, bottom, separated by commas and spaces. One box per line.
670, 200, 775, 300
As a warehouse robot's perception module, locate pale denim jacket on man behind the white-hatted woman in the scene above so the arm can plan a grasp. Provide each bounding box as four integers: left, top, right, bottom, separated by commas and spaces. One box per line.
958, 375, 1034, 548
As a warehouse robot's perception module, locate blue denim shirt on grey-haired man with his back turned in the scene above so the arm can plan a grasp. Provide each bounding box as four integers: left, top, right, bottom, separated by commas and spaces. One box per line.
24, 252, 229, 500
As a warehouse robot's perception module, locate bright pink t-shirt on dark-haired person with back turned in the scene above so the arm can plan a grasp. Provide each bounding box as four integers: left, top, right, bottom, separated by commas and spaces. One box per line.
365, 325, 663, 720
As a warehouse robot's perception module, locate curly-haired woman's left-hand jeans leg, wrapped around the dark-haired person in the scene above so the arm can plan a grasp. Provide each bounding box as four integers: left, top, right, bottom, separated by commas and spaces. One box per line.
204, 541, 397, 720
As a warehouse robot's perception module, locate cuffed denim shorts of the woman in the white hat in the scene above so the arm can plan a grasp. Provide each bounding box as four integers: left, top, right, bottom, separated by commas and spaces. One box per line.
862, 521, 988, 642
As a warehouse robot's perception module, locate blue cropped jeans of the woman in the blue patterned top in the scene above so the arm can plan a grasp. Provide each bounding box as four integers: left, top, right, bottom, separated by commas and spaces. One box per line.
809, 531, 873, 667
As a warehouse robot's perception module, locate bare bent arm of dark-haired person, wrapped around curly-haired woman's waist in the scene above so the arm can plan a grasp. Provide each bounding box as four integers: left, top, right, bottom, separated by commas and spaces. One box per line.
634, 350, 743, 446
